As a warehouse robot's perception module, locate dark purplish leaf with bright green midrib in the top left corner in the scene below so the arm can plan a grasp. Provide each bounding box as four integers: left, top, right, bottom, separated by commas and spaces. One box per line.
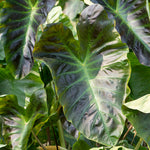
1, 0, 55, 77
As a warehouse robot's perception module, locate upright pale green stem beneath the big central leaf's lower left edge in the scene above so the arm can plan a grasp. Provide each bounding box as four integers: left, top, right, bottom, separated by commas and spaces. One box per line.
57, 120, 66, 148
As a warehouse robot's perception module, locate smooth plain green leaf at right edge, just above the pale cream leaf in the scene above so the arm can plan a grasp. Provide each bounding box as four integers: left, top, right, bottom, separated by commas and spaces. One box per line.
128, 52, 150, 100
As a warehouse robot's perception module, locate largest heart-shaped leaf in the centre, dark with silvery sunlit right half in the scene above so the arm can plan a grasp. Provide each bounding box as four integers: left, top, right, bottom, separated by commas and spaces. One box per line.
34, 5, 130, 145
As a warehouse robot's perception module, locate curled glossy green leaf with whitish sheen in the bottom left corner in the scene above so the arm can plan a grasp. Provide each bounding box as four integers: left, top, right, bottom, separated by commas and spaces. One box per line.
0, 89, 48, 150
